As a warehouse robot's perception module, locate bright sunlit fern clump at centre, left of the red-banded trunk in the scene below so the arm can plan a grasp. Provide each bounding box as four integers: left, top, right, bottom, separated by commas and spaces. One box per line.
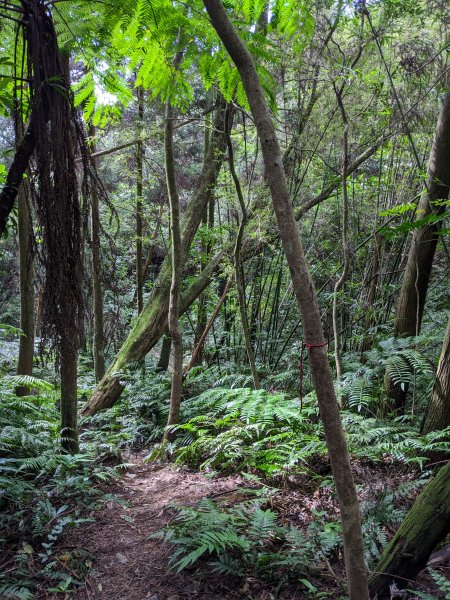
167, 388, 325, 475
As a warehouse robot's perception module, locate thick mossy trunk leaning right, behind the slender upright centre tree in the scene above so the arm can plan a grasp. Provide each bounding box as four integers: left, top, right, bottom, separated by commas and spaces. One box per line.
83, 103, 229, 415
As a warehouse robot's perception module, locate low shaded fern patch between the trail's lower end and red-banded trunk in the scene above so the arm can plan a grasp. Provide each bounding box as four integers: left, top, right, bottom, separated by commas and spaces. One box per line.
157, 488, 340, 583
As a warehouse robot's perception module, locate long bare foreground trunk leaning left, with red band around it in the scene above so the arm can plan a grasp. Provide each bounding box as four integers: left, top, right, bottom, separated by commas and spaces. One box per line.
203, 0, 369, 600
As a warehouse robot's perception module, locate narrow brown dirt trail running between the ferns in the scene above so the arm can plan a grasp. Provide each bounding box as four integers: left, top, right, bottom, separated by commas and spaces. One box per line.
60, 456, 248, 600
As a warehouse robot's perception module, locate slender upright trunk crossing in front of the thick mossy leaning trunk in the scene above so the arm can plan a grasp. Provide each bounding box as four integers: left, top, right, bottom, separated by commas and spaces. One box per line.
164, 90, 183, 440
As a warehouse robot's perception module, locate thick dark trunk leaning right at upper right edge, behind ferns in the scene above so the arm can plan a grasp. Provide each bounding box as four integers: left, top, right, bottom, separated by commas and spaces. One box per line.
385, 92, 450, 412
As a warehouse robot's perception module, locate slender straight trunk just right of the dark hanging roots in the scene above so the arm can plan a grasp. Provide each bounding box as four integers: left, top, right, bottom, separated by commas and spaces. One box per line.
89, 124, 105, 382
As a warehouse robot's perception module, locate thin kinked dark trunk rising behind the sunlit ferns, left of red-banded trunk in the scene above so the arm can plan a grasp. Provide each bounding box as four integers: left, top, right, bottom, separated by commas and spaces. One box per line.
225, 110, 261, 390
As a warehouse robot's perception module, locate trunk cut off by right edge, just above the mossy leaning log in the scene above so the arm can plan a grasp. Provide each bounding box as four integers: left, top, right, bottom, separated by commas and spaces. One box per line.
420, 316, 450, 438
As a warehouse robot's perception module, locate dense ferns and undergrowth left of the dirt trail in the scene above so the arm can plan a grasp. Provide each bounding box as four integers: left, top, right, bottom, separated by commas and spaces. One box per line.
0, 376, 121, 598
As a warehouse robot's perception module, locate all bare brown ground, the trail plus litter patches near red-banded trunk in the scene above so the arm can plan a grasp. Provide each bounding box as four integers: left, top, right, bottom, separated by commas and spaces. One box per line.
39, 455, 450, 600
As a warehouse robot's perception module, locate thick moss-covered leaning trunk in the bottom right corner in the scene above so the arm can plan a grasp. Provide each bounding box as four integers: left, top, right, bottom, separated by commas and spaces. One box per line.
369, 462, 450, 600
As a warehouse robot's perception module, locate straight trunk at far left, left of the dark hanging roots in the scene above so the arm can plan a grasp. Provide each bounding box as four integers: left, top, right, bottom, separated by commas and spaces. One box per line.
16, 170, 34, 396
